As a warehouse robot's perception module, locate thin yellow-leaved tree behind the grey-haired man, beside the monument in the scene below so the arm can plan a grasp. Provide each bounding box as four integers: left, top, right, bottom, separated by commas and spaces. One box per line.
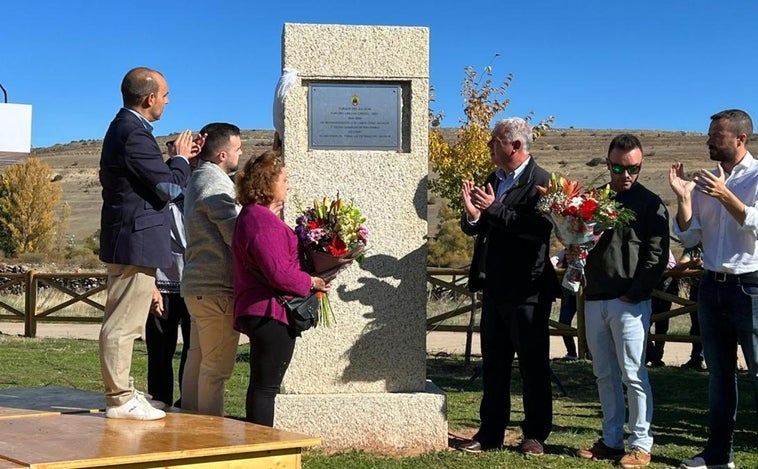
429, 62, 554, 212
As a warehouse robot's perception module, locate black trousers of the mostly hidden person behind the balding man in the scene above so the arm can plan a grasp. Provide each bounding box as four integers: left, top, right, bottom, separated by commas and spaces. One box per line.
145, 293, 190, 407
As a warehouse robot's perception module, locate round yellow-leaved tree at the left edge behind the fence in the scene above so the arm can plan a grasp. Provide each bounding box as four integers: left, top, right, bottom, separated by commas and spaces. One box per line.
0, 158, 63, 255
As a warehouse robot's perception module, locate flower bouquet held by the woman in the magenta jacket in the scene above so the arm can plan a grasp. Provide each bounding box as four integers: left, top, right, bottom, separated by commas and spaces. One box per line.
295, 193, 368, 327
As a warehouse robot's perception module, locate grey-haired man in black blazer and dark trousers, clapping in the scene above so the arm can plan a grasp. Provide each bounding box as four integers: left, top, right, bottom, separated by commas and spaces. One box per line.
460, 118, 561, 455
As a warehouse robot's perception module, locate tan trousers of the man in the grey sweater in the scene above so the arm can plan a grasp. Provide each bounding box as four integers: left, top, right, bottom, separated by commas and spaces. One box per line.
182, 295, 240, 416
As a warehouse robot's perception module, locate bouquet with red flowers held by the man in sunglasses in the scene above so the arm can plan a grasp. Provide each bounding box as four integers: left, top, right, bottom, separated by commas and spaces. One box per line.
537, 173, 635, 292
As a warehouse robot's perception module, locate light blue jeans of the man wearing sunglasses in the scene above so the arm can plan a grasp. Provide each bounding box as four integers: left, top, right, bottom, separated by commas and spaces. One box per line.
584, 299, 653, 453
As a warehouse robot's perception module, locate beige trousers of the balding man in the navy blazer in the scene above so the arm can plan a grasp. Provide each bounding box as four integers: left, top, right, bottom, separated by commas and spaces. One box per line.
100, 264, 155, 406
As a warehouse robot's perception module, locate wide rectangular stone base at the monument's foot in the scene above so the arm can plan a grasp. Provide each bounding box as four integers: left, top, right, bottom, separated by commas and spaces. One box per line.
274, 380, 448, 453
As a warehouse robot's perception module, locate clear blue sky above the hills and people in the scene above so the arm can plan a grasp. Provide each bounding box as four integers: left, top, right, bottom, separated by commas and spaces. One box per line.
0, 0, 758, 147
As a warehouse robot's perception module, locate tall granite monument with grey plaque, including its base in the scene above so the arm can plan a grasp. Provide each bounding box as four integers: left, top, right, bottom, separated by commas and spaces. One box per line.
275, 23, 447, 450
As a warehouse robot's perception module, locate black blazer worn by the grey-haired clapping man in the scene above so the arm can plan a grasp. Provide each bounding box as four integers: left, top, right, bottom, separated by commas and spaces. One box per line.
461, 158, 561, 302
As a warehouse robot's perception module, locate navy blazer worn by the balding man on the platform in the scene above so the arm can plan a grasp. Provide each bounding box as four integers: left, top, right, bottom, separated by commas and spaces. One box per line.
100, 109, 190, 268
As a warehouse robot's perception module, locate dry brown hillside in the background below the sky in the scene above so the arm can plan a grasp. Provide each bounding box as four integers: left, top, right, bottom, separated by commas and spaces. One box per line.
32, 126, 712, 247
